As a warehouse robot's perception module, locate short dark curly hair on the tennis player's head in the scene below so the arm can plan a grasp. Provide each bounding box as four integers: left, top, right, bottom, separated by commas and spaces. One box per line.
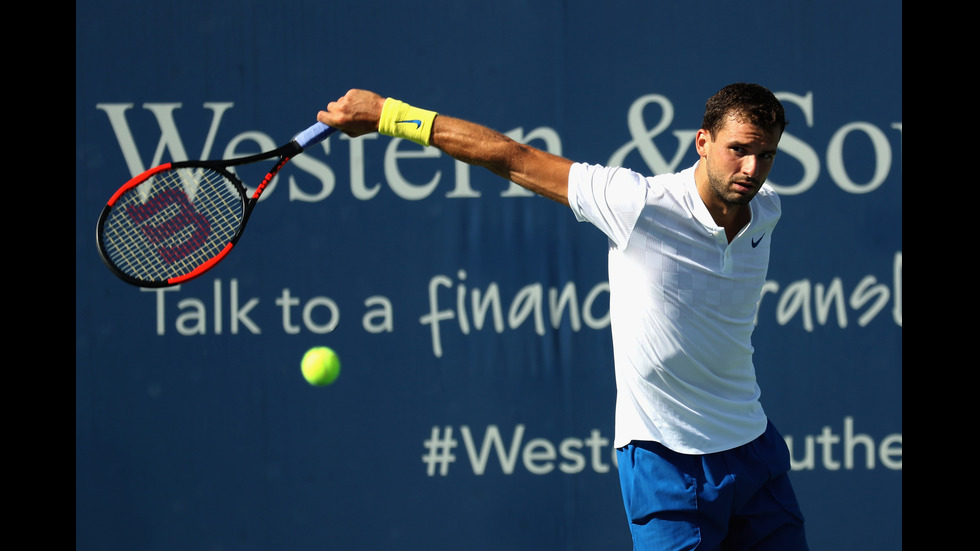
701, 82, 786, 136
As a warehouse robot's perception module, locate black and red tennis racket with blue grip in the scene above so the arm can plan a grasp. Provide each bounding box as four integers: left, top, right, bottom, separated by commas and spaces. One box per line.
97, 122, 336, 287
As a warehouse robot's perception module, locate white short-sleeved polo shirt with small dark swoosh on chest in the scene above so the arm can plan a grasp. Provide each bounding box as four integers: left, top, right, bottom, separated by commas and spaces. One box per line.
568, 164, 780, 454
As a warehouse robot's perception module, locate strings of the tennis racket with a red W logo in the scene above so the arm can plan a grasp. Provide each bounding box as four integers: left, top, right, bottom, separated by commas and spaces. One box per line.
102, 167, 245, 281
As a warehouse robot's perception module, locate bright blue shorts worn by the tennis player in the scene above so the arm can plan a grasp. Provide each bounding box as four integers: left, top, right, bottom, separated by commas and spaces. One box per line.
617, 423, 807, 551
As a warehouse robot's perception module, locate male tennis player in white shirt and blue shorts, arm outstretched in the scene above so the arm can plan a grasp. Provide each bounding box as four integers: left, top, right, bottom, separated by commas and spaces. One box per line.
317, 83, 807, 551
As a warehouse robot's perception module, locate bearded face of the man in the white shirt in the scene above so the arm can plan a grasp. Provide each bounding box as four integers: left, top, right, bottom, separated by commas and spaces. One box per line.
696, 117, 781, 208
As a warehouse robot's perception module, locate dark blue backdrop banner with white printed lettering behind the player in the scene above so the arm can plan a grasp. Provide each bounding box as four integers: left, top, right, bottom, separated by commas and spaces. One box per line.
75, 0, 902, 551
